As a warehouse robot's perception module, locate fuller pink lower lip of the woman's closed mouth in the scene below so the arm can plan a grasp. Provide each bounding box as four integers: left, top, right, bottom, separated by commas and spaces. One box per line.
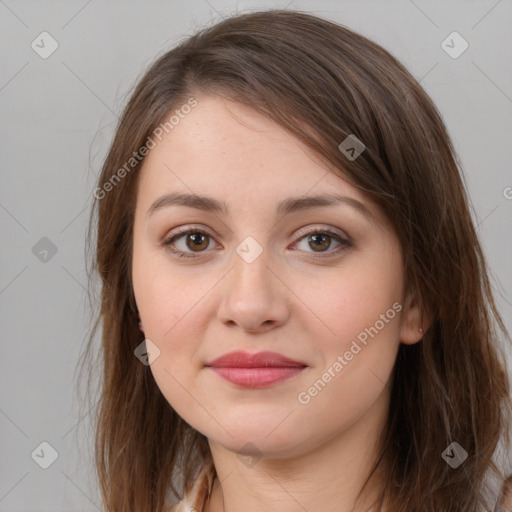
210, 366, 305, 388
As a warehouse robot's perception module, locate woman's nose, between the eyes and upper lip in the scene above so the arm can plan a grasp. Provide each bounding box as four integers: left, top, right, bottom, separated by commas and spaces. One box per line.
218, 245, 292, 333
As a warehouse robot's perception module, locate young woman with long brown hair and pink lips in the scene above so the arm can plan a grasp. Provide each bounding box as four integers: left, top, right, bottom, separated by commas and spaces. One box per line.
82, 10, 510, 512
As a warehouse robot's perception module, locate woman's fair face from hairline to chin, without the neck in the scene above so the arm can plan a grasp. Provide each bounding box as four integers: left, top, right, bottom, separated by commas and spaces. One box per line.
132, 97, 420, 458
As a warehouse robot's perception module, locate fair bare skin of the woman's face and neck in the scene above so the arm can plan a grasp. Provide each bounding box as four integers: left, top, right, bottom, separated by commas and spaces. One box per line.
132, 96, 427, 512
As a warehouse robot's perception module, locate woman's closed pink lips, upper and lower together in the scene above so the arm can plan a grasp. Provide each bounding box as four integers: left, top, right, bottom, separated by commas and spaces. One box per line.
205, 351, 307, 388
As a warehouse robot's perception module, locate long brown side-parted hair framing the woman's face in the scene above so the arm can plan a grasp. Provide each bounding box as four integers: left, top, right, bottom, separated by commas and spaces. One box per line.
78, 10, 511, 512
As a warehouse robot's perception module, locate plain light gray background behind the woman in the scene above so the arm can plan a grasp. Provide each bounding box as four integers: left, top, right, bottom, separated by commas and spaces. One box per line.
0, 0, 512, 512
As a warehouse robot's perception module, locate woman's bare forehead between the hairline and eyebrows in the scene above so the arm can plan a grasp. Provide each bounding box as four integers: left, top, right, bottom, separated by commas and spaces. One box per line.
139, 96, 388, 226
